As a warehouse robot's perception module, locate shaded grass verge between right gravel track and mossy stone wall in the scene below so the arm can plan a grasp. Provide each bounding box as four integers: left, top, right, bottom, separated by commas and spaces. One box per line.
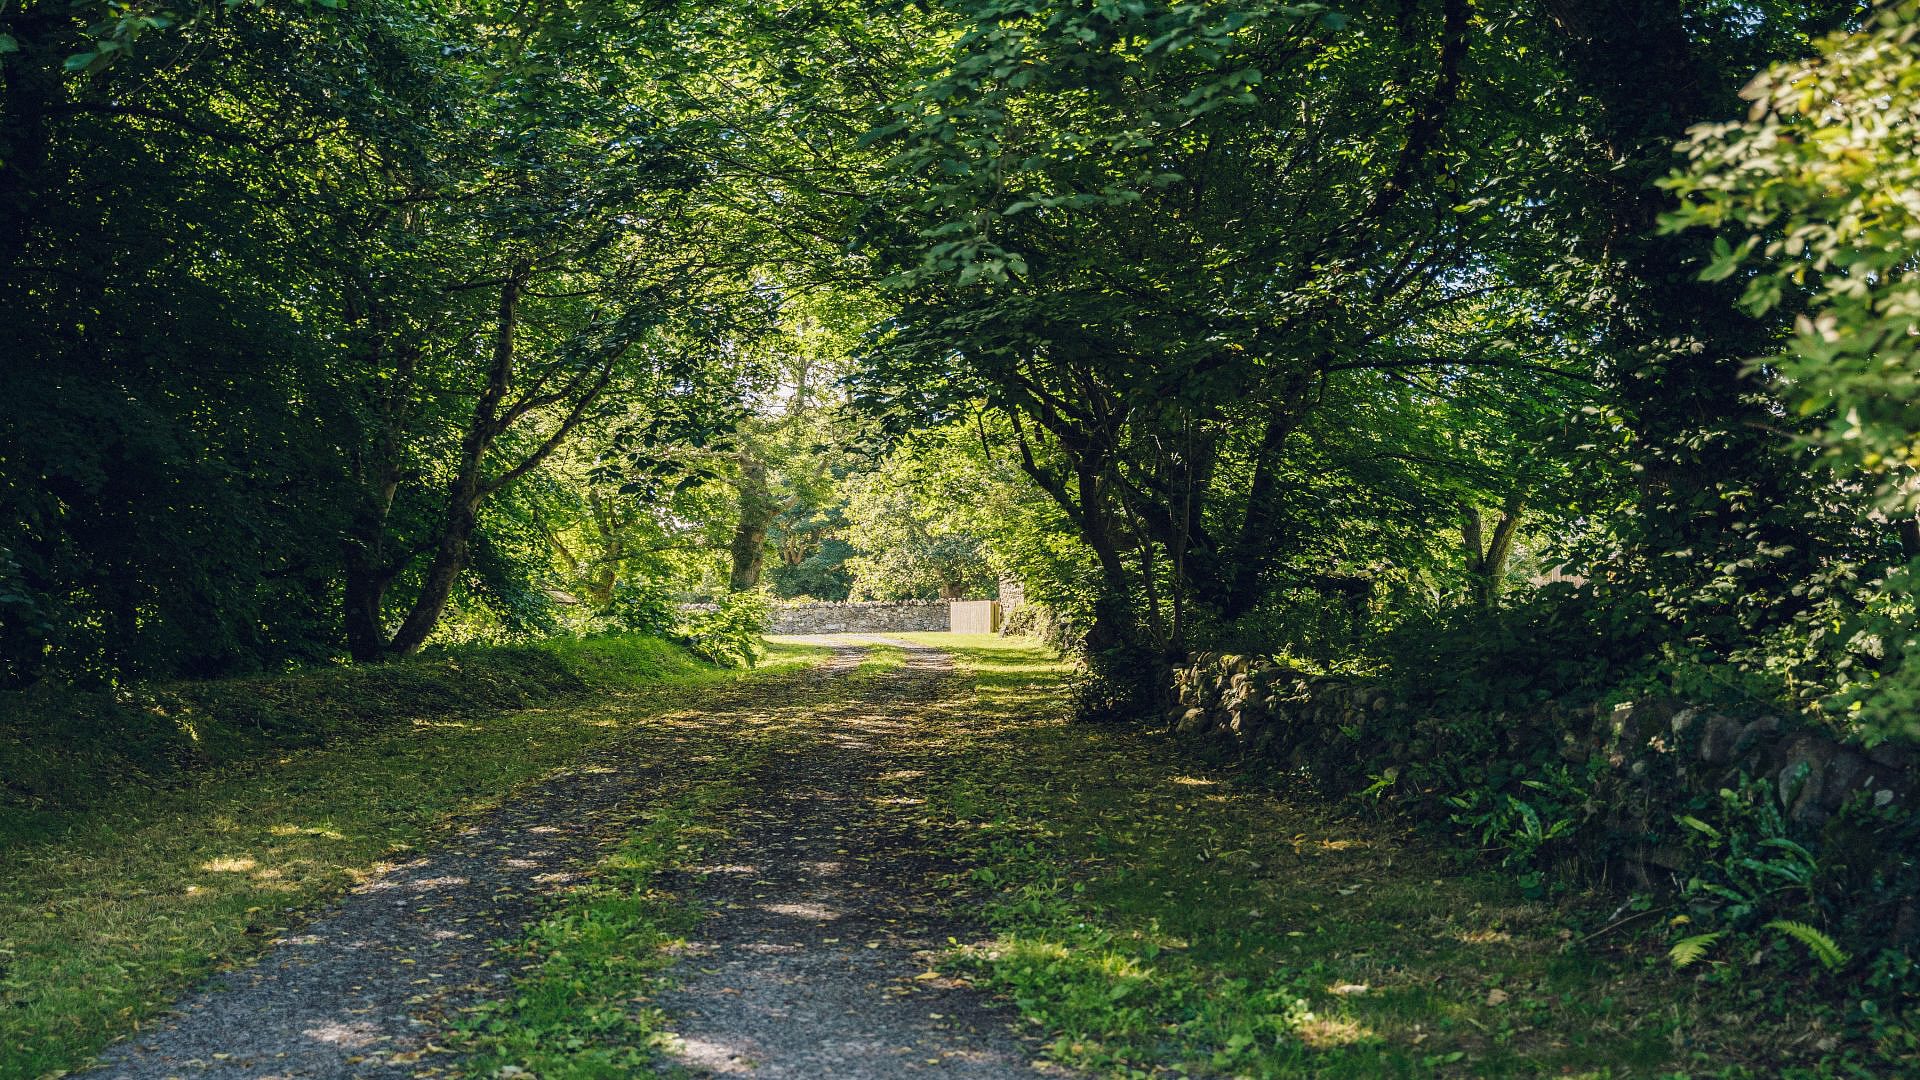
906, 634, 1858, 1076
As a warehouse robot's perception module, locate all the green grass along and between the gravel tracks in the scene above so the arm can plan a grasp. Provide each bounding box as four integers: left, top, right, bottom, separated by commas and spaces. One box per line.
11, 634, 1872, 1078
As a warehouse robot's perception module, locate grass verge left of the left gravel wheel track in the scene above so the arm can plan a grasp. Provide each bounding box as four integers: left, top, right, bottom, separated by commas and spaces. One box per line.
0, 638, 820, 1080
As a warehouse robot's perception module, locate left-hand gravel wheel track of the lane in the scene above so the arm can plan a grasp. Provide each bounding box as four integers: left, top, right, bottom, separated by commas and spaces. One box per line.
83, 691, 706, 1080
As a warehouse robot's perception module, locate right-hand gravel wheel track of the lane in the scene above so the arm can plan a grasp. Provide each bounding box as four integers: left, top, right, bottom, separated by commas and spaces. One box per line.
659, 642, 1060, 1080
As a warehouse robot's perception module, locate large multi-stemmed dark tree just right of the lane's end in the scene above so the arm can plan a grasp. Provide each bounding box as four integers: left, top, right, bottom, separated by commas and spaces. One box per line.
868, 2, 1578, 703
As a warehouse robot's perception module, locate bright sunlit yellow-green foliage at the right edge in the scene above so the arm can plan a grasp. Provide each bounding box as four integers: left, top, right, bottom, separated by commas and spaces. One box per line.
1663, 2, 1920, 736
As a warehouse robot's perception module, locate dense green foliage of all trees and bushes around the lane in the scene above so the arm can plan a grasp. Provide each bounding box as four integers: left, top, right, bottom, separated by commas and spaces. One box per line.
0, 0, 1920, 1060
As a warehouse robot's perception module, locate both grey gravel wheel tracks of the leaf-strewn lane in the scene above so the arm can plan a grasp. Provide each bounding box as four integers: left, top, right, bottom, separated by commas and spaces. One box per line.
84, 644, 1033, 1080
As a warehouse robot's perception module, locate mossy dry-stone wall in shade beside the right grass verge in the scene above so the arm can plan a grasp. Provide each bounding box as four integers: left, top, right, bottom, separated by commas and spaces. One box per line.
1167, 653, 1920, 944
